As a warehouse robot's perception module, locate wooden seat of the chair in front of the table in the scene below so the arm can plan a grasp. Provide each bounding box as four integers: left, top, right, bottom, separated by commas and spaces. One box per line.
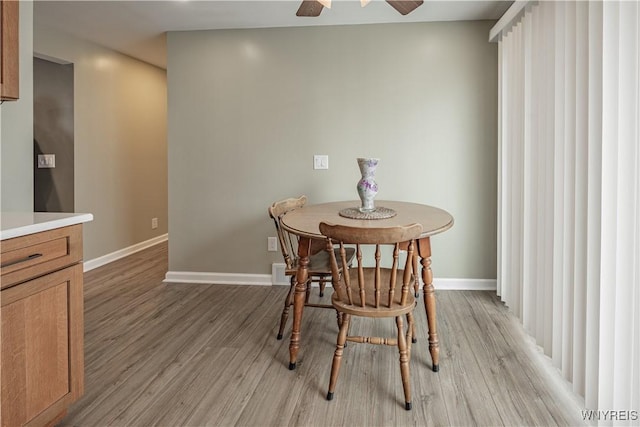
331, 268, 416, 317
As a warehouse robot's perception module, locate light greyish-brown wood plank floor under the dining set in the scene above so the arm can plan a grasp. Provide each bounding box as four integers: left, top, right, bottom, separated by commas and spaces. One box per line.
61, 244, 580, 426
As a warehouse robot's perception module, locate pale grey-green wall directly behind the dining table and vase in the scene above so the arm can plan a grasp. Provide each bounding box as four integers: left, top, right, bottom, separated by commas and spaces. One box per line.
168, 21, 497, 279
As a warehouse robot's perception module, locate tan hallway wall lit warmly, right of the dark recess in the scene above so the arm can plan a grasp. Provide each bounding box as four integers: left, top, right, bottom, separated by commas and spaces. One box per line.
29, 27, 168, 260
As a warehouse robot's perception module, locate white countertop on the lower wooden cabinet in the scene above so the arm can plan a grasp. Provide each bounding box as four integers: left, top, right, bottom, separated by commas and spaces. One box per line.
0, 212, 93, 240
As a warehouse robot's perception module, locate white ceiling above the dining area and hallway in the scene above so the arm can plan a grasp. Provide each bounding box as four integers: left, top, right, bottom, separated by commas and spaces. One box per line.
34, 0, 513, 68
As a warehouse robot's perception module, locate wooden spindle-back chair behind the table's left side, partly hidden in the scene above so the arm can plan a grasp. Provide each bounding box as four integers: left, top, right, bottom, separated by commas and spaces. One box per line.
269, 196, 355, 340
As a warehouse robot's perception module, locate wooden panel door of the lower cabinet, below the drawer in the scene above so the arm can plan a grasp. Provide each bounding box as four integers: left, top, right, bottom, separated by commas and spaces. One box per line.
0, 264, 84, 426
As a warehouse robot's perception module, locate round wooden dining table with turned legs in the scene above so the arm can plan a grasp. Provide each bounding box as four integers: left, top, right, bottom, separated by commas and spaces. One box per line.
281, 200, 453, 372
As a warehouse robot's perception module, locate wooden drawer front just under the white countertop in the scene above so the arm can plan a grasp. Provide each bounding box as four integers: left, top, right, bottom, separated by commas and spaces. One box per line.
0, 224, 82, 289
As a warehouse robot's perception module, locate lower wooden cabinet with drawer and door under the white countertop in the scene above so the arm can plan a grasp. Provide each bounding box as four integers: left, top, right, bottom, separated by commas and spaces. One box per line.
0, 224, 84, 426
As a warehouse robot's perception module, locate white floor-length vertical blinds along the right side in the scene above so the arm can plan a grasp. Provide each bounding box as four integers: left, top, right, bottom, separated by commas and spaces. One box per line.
498, 1, 640, 411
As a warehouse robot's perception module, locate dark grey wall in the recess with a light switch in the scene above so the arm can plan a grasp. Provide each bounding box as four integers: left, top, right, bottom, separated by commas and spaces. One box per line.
33, 58, 75, 212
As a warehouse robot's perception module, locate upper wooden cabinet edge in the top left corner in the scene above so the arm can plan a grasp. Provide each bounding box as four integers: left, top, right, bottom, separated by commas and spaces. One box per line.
0, 0, 20, 101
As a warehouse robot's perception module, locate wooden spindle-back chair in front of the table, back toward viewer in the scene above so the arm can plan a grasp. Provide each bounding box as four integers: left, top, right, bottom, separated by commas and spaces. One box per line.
320, 222, 422, 410
